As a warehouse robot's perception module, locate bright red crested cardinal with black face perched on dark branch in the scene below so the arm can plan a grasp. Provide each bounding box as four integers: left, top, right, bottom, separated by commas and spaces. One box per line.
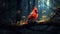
26, 6, 38, 23
